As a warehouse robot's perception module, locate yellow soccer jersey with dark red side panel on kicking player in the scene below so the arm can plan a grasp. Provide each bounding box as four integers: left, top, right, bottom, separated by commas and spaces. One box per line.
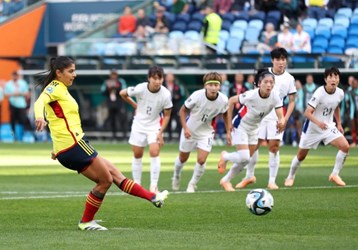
34, 80, 84, 154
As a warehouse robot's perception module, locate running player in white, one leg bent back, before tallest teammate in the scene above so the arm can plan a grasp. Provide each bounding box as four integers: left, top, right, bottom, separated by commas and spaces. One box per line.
218, 69, 285, 192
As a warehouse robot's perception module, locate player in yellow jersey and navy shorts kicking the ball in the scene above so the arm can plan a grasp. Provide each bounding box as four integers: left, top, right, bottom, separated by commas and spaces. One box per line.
35, 56, 168, 230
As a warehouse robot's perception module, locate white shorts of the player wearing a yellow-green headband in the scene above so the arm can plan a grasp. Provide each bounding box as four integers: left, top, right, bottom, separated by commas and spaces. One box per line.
179, 130, 215, 153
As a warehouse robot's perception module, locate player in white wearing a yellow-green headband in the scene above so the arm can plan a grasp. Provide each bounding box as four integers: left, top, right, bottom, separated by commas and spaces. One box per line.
172, 72, 230, 193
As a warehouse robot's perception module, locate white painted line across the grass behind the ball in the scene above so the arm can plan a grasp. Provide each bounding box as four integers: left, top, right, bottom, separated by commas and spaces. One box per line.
0, 185, 358, 200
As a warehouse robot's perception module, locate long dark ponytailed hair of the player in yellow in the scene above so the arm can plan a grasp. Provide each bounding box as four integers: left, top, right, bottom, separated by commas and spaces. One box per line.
36, 56, 74, 91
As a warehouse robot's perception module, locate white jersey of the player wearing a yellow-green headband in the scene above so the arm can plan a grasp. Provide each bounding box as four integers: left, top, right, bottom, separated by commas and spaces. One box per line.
184, 89, 228, 138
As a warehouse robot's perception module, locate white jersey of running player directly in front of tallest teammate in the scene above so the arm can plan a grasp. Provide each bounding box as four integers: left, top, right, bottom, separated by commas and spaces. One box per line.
233, 89, 282, 131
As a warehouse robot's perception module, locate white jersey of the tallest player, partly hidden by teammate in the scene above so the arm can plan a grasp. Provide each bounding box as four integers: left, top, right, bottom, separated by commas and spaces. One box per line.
265, 68, 297, 121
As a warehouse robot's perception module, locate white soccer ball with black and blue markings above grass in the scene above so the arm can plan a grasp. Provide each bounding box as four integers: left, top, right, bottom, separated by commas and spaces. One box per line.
246, 188, 273, 215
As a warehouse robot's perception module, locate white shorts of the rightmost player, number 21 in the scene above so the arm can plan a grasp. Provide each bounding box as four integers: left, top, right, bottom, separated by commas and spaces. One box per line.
299, 127, 343, 149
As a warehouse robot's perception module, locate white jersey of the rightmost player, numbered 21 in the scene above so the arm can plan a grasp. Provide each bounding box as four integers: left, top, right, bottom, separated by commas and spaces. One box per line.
302, 86, 344, 133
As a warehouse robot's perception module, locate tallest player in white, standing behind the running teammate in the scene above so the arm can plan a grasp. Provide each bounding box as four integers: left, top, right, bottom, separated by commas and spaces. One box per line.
236, 48, 296, 189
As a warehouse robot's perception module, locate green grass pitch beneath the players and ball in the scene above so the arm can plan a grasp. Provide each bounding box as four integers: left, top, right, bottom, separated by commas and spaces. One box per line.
0, 142, 358, 250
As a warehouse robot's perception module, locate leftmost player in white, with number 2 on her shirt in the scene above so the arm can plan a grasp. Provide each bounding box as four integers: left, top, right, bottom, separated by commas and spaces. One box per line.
120, 66, 173, 192
